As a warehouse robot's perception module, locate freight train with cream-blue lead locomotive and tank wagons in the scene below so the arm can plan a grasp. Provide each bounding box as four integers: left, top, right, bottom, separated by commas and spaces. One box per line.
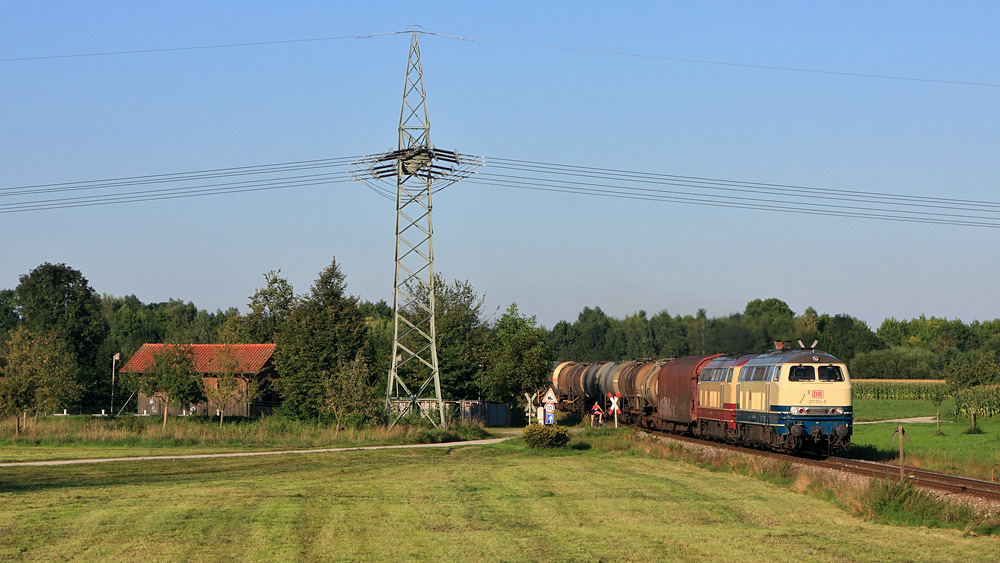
552, 342, 853, 456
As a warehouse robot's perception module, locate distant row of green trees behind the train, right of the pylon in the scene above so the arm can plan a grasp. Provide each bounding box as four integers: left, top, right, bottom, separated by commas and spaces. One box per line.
547, 298, 1000, 388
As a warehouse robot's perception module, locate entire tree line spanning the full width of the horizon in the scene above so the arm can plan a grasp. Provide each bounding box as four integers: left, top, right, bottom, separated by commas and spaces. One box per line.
0, 259, 1000, 425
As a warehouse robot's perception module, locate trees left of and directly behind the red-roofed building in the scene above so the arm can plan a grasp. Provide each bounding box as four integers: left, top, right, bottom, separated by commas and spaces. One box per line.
0, 263, 237, 418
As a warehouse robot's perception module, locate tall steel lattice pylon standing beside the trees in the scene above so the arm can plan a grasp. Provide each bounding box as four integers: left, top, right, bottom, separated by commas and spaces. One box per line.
355, 32, 482, 425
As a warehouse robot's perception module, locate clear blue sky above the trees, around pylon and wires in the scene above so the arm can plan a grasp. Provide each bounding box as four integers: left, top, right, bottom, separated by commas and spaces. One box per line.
0, 2, 1000, 328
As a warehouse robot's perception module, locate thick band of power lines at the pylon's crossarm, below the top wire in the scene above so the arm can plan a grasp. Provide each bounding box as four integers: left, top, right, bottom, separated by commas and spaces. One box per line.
7, 155, 1000, 228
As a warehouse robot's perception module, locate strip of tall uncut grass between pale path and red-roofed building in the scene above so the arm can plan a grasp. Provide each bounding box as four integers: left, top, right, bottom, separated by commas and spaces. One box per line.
0, 416, 490, 462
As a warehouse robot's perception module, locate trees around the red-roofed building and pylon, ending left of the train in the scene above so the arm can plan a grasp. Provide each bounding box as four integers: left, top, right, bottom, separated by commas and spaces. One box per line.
0, 260, 552, 425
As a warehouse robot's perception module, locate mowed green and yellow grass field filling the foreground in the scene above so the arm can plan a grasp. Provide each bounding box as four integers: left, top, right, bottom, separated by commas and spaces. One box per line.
0, 438, 1000, 562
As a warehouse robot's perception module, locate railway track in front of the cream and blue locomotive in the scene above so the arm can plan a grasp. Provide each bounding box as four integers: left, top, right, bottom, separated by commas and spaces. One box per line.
649, 432, 1000, 503
